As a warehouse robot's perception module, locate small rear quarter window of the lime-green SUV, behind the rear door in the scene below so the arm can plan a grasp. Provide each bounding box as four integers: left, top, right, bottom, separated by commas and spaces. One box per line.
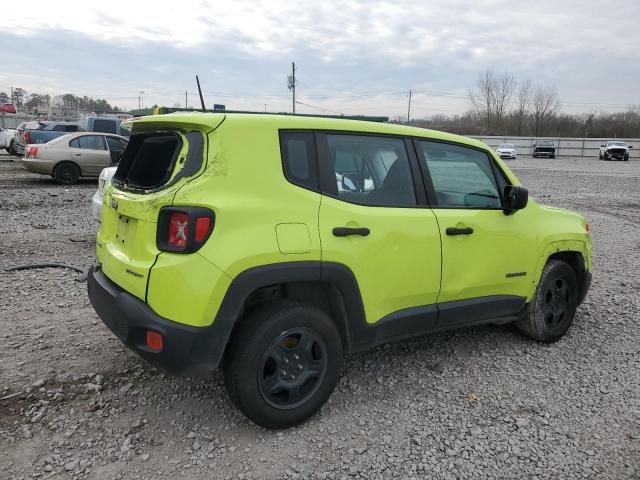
280, 132, 319, 191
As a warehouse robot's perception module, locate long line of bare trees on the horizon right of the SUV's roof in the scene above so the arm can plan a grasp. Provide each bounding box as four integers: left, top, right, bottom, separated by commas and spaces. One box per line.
398, 69, 640, 138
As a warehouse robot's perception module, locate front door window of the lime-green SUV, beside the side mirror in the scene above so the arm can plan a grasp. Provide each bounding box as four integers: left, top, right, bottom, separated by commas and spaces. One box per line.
420, 141, 502, 209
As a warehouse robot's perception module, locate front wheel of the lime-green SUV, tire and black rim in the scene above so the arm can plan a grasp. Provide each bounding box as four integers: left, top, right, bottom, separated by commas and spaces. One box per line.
516, 260, 578, 342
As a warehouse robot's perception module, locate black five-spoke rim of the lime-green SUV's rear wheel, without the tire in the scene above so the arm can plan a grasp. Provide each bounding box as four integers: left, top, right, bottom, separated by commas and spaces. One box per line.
258, 328, 328, 409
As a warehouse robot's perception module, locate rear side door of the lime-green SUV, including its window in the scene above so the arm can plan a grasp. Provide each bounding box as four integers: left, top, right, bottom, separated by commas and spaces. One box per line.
318, 133, 441, 330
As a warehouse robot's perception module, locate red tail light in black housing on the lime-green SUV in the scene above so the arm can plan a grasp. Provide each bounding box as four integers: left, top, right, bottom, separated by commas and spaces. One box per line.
156, 207, 215, 253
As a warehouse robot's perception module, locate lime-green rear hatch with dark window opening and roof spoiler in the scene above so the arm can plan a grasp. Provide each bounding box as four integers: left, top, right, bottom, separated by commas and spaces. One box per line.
97, 113, 224, 300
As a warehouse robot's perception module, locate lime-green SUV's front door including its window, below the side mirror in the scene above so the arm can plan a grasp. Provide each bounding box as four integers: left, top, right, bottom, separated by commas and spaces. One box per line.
416, 140, 536, 323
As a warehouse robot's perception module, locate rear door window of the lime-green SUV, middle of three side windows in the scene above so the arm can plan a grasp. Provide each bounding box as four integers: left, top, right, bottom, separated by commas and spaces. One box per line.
327, 134, 416, 206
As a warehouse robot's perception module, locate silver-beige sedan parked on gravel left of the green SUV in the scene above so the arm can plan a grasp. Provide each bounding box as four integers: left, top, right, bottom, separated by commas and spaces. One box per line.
23, 132, 127, 185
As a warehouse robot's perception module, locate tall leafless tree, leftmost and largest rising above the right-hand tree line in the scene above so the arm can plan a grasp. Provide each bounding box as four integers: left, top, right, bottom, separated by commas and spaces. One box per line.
469, 69, 517, 129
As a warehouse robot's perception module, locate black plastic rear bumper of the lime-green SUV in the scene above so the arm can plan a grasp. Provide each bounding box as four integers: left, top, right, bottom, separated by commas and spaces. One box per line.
87, 266, 228, 376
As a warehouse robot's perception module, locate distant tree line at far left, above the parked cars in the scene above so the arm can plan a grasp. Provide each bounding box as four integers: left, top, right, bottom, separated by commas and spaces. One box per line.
0, 88, 121, 114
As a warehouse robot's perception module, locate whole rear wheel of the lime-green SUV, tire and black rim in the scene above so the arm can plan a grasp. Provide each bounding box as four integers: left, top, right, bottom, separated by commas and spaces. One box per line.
223, 302, 344, 429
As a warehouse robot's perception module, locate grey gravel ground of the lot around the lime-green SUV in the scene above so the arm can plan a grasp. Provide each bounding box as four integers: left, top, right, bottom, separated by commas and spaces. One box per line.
0, 151, 640, 479
